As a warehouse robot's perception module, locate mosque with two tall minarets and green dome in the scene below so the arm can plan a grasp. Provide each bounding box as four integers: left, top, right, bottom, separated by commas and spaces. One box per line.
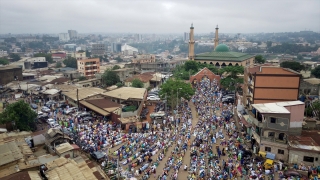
188, 24, 254, 68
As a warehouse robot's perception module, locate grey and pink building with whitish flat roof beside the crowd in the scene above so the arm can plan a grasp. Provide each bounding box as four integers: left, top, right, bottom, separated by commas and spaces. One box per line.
248, 101, 305, 161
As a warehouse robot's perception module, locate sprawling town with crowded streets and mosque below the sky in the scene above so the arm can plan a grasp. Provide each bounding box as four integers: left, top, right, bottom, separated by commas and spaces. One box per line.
0, 24, 320, 180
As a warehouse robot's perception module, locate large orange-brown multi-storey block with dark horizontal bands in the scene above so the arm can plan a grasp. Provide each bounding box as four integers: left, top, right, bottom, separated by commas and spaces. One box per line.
242, 66, 301, 110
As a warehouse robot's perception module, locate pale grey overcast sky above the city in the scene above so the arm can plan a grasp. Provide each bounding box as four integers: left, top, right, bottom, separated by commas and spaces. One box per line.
0, 0, 320, 34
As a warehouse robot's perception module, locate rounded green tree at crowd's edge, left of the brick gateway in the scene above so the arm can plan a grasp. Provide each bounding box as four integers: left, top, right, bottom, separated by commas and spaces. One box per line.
159, 79, 194, 107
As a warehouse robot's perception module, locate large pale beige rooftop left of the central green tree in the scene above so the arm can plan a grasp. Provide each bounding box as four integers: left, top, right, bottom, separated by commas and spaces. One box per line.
103, 87, 147, 100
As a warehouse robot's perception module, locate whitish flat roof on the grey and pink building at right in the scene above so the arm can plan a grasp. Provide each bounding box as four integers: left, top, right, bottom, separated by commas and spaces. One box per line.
252, 101, 304, 114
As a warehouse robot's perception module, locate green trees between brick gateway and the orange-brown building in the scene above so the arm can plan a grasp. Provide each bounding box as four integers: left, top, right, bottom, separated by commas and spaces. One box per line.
220, 66, 244, 91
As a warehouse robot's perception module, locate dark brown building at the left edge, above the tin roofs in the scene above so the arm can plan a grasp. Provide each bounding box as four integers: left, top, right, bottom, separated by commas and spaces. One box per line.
0, 66, 23, 85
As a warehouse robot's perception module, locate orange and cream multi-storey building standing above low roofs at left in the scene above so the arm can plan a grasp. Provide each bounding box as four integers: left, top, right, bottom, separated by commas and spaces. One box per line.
77, 58, 100, 77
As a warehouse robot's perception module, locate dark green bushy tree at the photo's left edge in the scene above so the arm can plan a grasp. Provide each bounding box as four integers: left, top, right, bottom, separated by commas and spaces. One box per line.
0, 101, 37, 131
